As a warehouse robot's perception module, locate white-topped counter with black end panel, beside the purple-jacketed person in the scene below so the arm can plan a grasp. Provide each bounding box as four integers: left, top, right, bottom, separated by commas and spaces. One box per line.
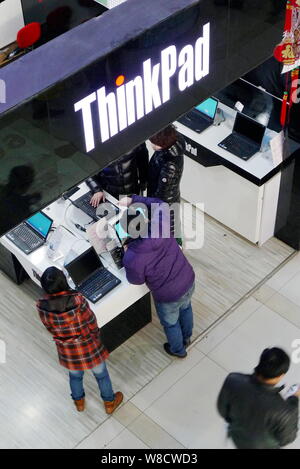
0, 183, 151, 351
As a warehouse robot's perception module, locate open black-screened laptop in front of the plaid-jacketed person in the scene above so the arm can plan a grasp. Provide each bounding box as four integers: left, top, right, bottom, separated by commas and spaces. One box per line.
65, 247, 121, 303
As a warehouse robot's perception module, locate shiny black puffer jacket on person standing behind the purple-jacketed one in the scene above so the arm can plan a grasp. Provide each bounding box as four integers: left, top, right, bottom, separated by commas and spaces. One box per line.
148, 137, 185, 204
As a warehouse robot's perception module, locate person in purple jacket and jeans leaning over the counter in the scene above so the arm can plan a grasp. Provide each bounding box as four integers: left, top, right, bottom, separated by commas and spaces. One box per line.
120, 195, 195, 358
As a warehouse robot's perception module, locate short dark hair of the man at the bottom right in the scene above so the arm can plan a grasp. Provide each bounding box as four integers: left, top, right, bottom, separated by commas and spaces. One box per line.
255, 347, 290, 379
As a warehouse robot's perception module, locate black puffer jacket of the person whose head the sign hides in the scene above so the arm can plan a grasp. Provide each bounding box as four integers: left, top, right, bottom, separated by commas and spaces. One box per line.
86, 143, 149, 199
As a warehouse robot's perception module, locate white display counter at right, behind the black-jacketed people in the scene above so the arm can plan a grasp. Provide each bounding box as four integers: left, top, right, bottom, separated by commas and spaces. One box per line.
175, 102, 298, 245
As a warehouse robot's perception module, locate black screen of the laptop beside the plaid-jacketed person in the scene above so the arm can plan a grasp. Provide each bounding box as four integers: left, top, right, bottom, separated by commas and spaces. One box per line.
65, 248, 103, 285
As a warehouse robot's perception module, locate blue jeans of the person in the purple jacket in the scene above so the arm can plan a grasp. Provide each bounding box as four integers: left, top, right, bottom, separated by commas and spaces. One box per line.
155, 284, 195, 355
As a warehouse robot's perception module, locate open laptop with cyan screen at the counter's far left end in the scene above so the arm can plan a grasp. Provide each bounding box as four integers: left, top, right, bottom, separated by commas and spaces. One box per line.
6, 212, 53, 254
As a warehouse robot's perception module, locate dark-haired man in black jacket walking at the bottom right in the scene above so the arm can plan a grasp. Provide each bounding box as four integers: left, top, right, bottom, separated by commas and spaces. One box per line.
217, 347, 300, 449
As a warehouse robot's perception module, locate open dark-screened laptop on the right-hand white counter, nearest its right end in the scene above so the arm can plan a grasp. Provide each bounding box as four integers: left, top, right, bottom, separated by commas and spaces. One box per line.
218, 112, 266, 161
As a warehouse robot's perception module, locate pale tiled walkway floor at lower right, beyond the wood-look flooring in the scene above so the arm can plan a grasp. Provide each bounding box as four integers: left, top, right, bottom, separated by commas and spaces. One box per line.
79, 253, 300, 449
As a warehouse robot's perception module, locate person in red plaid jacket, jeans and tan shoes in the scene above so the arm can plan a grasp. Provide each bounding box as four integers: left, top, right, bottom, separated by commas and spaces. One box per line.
37, 267, 123, 414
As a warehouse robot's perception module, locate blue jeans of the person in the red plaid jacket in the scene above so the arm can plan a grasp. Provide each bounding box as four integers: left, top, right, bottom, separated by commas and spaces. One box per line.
69, 362, 115, 402
